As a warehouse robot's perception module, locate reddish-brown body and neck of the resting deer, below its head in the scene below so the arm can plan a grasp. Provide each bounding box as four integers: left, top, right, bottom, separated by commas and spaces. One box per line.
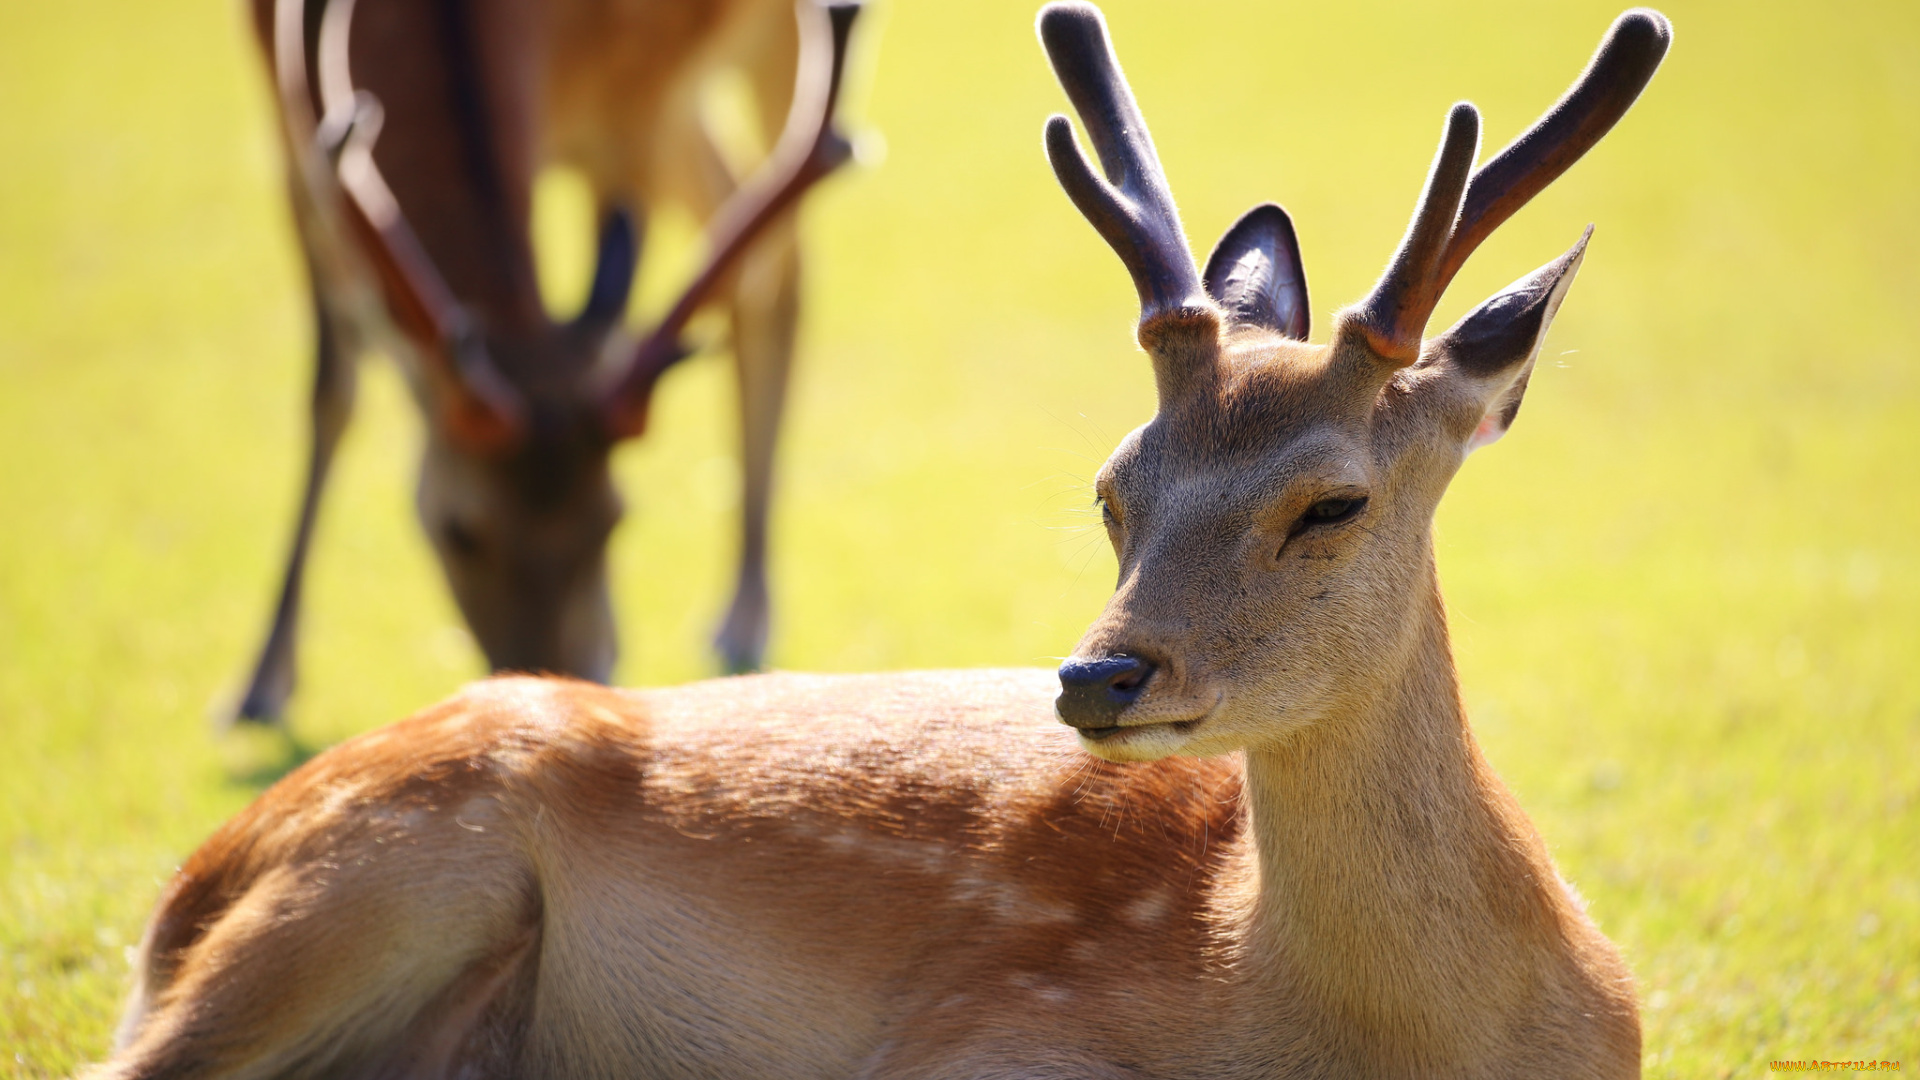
100, 614, 1638, 1076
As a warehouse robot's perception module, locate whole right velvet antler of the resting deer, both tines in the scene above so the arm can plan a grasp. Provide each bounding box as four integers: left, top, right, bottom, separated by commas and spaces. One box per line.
1350, 8, 1672, 365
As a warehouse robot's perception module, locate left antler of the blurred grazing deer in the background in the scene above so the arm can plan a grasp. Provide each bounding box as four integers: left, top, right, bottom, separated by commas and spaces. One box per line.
275, 0, 526, 452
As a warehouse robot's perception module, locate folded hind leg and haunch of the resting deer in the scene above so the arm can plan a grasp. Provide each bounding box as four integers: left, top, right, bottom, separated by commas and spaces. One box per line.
86, 798, 541, 1080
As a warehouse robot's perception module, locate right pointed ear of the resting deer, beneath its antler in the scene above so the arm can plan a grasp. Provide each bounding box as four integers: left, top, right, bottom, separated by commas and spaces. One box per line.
1434, 225, 1594, 450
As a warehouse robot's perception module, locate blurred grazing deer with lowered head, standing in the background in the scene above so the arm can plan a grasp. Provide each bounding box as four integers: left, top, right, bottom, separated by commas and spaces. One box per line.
234, 0, 852, 723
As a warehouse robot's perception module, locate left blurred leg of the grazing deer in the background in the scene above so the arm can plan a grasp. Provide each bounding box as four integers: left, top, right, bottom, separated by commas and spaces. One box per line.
234, 278, 357, 724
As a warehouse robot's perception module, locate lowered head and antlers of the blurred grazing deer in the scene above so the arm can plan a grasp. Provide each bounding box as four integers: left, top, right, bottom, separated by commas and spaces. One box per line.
275, 0, 858, 680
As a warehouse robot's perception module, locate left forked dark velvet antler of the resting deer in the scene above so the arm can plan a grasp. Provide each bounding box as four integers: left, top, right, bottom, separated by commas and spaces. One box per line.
1039, 2, 1208, 323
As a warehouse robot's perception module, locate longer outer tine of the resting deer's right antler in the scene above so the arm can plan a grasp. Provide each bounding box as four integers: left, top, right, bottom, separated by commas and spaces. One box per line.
1438, 8, 1674, 292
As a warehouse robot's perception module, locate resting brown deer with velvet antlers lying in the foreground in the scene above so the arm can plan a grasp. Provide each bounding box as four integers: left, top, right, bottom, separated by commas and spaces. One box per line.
94, 2, 1672, 1080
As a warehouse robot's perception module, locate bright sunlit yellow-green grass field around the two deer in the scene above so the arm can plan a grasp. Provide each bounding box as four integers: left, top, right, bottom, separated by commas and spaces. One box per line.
0, 0, 1920, 1078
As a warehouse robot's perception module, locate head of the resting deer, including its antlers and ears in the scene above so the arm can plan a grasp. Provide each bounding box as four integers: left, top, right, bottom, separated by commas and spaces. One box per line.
1039, 4, 1670, 761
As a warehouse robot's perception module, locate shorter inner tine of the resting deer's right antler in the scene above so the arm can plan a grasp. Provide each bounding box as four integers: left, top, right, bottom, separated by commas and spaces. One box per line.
1354, 102, 1480, 365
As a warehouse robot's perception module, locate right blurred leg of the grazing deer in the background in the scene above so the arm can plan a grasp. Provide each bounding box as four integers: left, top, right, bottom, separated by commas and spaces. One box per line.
714, 221, 801, 673
